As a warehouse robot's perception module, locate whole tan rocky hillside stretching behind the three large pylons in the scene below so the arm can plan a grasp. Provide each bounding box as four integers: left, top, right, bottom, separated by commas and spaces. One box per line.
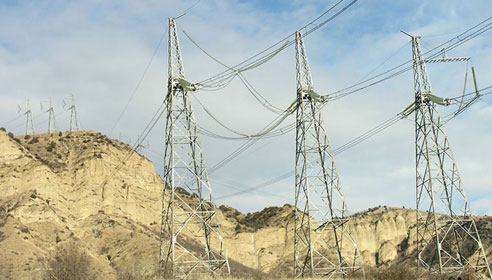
0, 131, 492, 279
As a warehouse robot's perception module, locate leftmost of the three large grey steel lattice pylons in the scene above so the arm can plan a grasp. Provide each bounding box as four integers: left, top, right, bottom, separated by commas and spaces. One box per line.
159, 18, 230, 278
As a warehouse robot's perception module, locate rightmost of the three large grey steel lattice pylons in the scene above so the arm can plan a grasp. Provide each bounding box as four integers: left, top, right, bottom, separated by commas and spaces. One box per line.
407, 34, 492, 278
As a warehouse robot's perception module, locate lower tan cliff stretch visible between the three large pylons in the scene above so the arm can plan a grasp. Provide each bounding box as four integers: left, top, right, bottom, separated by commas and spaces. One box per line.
221, 205, 416, 275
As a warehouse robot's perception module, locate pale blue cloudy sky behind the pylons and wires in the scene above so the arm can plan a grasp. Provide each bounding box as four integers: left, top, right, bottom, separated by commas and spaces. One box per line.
0, 0, 492, 214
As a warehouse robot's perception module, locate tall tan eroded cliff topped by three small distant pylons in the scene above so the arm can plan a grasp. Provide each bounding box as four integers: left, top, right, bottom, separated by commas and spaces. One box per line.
0, 131, 162, 279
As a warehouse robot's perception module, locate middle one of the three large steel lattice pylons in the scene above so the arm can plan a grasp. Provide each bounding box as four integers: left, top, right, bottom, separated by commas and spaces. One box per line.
294, 31, 364, 278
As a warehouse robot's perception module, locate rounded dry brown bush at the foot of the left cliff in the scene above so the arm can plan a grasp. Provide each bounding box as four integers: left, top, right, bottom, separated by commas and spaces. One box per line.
44, 243, 96, 280
